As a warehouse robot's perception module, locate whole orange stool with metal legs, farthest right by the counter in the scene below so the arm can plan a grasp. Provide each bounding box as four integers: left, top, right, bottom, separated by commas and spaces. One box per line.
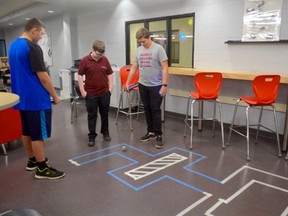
227, 75, 281, 160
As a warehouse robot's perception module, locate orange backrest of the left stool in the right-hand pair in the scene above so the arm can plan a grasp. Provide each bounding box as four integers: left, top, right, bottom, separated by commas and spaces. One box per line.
194, 72, 222, 100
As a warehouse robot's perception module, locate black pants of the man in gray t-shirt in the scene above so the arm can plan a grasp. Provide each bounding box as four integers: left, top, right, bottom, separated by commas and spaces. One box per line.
139, 83, 163, 135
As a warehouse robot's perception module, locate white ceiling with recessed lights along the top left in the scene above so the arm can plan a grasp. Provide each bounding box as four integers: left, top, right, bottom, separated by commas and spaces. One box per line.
0, 0, 179, 30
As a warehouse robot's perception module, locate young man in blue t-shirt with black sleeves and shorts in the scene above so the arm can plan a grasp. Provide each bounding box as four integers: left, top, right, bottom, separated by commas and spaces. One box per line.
8, 18, 65, 179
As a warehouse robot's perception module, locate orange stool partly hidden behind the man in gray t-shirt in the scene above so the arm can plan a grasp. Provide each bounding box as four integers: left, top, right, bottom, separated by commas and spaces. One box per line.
116, 65, 144, 131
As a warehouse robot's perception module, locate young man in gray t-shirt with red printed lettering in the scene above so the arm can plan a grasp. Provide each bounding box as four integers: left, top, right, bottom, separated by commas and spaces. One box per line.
125, 28, 168, 149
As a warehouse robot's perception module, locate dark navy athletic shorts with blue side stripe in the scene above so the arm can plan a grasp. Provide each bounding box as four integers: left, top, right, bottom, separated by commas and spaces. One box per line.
20, 110, 52, 141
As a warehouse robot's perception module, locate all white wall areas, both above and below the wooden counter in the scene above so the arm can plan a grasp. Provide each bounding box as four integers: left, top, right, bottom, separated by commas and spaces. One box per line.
5, 0, 288, 132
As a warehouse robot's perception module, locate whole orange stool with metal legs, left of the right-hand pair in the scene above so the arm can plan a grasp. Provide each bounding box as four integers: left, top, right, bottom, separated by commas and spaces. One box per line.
184, 72, 225, 149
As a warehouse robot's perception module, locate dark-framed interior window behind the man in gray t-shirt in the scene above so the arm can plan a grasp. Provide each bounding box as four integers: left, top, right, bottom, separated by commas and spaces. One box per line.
125, 14, 194, 68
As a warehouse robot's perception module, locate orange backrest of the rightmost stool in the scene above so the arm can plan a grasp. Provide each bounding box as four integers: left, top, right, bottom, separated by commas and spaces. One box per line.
252, 75, 280, 104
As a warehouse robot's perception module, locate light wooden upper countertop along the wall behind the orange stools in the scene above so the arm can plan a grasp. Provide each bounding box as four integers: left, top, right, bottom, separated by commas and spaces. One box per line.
169, 67, 288, 84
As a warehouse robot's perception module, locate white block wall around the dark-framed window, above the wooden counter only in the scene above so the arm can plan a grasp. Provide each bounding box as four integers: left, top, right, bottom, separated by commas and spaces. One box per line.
71, 0, 288, 73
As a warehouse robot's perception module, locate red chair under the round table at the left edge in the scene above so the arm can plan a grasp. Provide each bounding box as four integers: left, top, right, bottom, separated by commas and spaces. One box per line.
0, 107, 22, 155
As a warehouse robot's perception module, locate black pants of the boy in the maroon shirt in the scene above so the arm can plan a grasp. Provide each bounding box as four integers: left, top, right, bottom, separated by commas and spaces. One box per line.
86, 91, 111, 139
